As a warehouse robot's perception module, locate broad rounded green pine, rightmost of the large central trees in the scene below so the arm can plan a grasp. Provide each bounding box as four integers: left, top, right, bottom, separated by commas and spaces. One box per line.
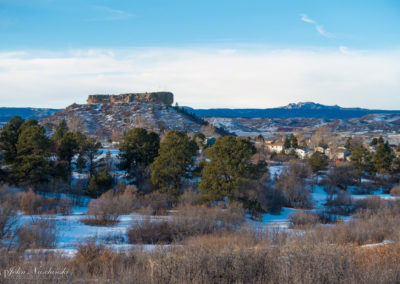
199, 136, 267, 202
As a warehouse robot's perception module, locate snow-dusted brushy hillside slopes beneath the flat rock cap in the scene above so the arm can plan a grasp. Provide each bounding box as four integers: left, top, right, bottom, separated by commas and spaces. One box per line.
40, 101, 225, 141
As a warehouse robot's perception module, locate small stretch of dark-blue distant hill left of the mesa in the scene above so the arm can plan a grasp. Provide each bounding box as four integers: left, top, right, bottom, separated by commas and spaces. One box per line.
0, 107, 61, 126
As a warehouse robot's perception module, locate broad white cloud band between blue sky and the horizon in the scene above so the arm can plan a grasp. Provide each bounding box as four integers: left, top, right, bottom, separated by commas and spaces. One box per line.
0, 48, 400, 109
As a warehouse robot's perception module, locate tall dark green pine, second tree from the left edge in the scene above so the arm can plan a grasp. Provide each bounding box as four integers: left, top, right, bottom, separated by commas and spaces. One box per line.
12, 121, 51, 185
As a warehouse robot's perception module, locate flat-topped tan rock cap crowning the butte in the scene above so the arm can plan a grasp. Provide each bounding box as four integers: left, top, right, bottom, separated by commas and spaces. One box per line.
87, 92, 174, 106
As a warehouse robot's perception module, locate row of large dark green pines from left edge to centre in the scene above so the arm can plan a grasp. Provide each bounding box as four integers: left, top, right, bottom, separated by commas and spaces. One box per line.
0, 117, 268, 214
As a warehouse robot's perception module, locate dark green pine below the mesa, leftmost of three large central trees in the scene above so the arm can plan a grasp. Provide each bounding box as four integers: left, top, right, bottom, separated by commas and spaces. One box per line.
120, 128, 160, 187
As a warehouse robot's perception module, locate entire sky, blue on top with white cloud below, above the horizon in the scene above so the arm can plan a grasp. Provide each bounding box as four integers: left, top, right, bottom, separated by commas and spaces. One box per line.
0, 0, 400, 109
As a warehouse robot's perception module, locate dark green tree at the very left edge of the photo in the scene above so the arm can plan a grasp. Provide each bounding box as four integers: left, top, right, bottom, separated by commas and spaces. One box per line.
0, 116, 24, 164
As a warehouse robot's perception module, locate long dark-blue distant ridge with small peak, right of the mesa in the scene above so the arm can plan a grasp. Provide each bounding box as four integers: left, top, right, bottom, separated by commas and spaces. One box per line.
185, 102, 400, 119
